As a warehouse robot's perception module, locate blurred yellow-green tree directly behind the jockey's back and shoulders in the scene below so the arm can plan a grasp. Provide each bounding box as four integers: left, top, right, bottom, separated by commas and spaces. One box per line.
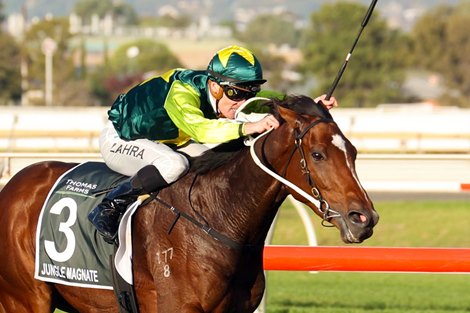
90, 39, 182, 105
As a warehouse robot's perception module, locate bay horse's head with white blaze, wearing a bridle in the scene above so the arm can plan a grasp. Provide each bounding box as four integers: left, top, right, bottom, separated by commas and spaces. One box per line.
265, 97, 379, 243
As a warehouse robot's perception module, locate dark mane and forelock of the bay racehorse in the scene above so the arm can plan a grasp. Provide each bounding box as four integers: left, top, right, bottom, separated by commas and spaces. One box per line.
189, 95, 333, 174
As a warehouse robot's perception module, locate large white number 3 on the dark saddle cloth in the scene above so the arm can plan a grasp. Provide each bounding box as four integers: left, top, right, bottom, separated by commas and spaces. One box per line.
44, 198, 77, 262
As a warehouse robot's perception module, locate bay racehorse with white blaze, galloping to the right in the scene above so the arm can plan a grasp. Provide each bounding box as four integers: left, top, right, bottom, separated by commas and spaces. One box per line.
0, 96, 378, 313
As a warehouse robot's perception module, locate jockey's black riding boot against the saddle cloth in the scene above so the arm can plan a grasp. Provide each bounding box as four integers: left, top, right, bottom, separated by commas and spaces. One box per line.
88, 165, 168, 243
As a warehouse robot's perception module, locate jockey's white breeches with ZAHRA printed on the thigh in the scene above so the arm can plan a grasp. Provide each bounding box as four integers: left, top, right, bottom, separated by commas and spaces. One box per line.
100, 123, 208, 183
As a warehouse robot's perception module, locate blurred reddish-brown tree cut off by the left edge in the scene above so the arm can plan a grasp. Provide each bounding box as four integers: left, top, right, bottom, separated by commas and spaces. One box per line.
0, 31, 21, 105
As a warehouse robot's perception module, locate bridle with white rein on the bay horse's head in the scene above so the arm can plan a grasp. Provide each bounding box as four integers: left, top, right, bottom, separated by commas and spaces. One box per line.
250, 118, 341, 227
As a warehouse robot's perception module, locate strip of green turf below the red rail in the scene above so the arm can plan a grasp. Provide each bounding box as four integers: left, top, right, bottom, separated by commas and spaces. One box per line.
267, 271, 470, 313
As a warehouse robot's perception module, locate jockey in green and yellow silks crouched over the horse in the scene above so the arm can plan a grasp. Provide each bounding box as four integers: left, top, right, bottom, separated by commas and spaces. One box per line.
88, 46, 336, 242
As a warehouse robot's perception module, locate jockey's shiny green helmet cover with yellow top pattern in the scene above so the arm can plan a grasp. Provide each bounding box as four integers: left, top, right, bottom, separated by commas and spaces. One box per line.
207, 46, 266, 85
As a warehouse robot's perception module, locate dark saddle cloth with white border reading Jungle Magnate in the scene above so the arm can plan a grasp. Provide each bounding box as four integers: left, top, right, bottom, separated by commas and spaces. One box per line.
34, 162, 141, 289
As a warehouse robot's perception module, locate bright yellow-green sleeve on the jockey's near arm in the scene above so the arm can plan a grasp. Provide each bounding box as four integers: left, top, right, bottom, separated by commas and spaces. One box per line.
165, 81, 240, 143
